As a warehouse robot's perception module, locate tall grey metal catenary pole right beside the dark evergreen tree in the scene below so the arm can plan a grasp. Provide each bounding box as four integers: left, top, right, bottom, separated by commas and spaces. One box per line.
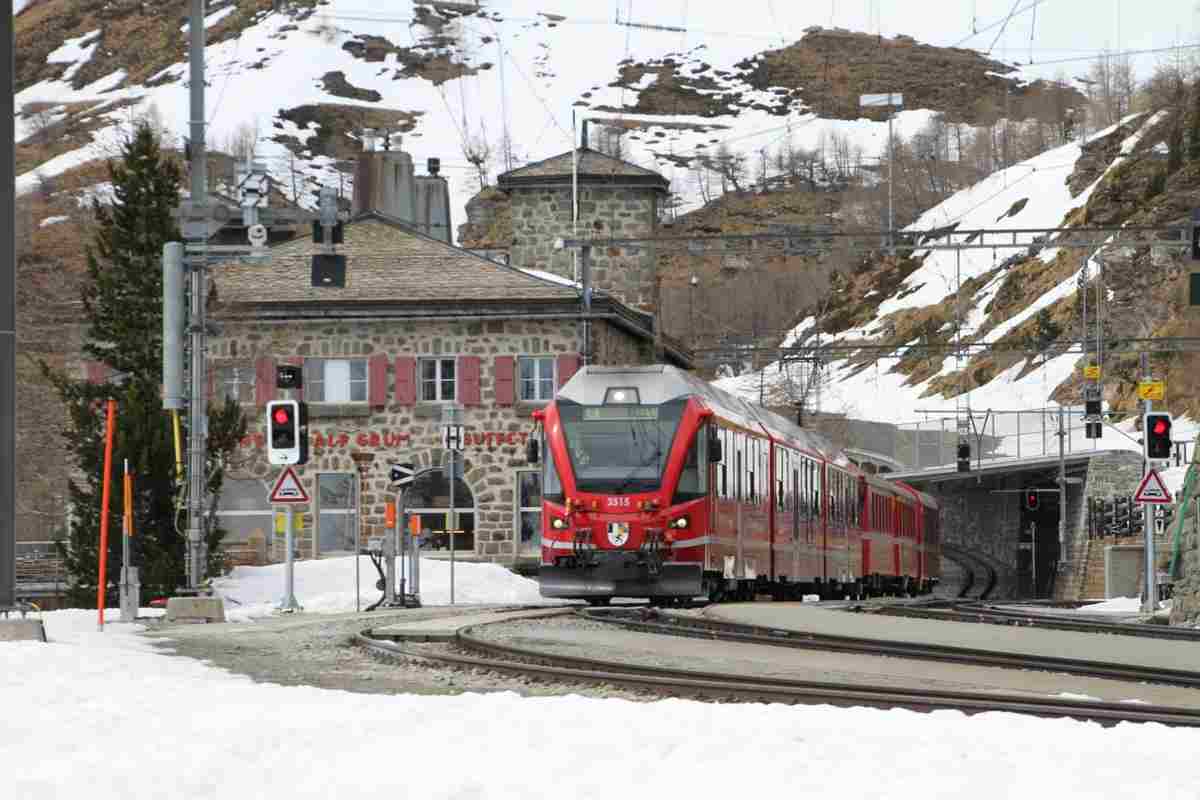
187, 0, 209, 590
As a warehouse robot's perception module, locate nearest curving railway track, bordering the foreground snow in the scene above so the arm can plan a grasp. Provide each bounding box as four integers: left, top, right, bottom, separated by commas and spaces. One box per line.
355, 610, 1200, 727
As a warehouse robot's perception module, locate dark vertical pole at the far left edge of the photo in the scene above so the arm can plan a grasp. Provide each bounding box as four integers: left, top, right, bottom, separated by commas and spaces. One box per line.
0, 0, 17, 610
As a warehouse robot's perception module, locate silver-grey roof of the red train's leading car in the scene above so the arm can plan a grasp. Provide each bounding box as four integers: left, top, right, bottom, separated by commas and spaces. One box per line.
558, 363, 854, 469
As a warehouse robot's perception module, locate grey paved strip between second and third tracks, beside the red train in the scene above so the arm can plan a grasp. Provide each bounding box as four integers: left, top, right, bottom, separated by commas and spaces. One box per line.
704, 603, 1200, 672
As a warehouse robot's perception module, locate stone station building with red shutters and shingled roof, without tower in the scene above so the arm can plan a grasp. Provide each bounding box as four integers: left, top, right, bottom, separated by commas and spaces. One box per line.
209, 212, 690, 565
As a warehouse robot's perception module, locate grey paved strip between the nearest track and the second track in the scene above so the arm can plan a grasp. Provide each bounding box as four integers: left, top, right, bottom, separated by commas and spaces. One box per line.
481, 619, 1200, 709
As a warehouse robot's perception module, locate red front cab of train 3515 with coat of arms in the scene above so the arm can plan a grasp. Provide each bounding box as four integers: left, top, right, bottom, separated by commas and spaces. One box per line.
536, 397, 720, 603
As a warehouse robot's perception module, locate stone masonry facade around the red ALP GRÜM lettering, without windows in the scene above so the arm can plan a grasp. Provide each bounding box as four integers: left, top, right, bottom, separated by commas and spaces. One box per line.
210, 320, 652, 563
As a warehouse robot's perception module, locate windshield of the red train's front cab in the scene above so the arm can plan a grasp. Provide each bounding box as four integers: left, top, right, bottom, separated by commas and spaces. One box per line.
558, 399, 685, 494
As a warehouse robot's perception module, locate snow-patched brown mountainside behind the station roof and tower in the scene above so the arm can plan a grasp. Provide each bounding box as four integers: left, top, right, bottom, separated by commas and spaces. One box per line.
16, 0, 1065, 235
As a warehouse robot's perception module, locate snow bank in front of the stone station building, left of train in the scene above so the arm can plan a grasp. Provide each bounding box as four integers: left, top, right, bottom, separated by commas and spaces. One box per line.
212, 555, 546, 621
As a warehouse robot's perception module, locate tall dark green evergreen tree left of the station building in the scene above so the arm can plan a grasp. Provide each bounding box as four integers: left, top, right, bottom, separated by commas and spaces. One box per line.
42, 125, 246, 606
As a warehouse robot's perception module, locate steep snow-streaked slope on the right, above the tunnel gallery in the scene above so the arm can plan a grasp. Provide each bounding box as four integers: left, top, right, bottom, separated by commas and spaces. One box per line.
718, 110, 1200, 449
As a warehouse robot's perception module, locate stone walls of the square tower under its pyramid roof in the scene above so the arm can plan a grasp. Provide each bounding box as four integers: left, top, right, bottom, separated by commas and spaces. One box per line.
511, 185, 659, 311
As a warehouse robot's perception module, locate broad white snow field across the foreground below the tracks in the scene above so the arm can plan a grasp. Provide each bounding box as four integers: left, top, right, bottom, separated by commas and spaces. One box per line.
7, 610, 1200, 800
